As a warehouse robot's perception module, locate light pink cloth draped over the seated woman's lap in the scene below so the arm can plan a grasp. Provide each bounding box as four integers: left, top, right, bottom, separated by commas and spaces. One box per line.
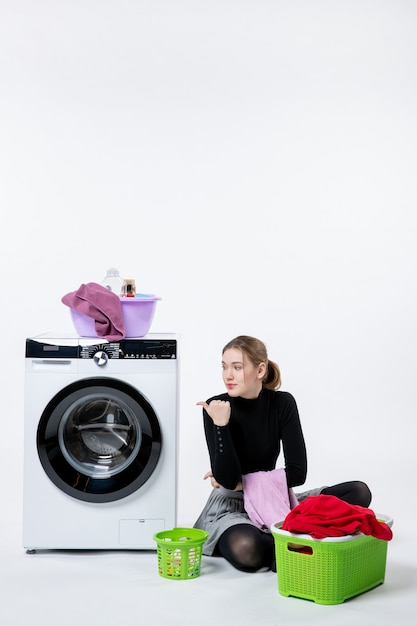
242, 469, 298, 530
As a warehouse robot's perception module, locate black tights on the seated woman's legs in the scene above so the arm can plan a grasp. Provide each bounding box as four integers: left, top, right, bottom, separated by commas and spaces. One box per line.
215, 481, 372, 572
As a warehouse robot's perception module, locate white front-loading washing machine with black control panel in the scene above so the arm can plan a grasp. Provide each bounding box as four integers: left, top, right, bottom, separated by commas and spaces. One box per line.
23, 333, 179, 552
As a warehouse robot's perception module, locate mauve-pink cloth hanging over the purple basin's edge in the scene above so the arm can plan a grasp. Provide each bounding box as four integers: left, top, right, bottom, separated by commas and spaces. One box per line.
61, 283, 125, 341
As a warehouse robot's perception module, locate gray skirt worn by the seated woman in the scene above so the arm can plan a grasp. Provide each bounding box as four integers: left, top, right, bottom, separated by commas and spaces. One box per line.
194, 486, 325, 556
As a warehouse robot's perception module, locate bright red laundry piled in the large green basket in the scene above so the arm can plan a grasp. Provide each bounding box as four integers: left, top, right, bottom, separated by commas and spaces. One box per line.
282, 494, 392, 541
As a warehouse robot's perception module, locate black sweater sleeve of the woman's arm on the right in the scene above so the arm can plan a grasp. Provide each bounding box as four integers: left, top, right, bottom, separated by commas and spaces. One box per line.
281, 393, 307, 487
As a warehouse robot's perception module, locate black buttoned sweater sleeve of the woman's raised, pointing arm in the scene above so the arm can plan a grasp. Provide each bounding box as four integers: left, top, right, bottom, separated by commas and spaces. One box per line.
203, 409, 242, 489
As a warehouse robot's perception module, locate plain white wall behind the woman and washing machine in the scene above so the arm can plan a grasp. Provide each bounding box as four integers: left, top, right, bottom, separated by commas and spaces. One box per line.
0, 0, 417, 523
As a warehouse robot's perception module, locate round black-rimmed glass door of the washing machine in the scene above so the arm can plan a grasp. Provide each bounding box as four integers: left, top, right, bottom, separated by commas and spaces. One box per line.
37, 378, 162, 502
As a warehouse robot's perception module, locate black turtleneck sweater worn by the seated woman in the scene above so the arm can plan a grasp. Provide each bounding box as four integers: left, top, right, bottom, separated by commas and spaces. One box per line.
203, 389, 307, 489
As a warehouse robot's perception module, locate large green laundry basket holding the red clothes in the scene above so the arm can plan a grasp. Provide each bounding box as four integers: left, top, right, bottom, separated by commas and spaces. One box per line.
271, 516, 392, 604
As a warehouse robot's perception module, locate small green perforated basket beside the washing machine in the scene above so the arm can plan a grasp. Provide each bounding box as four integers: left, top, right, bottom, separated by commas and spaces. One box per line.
153, 528, 208, 580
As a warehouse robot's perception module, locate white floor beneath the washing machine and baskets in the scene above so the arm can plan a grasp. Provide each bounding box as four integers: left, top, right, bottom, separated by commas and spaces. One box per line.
0, 504, 417, 626
